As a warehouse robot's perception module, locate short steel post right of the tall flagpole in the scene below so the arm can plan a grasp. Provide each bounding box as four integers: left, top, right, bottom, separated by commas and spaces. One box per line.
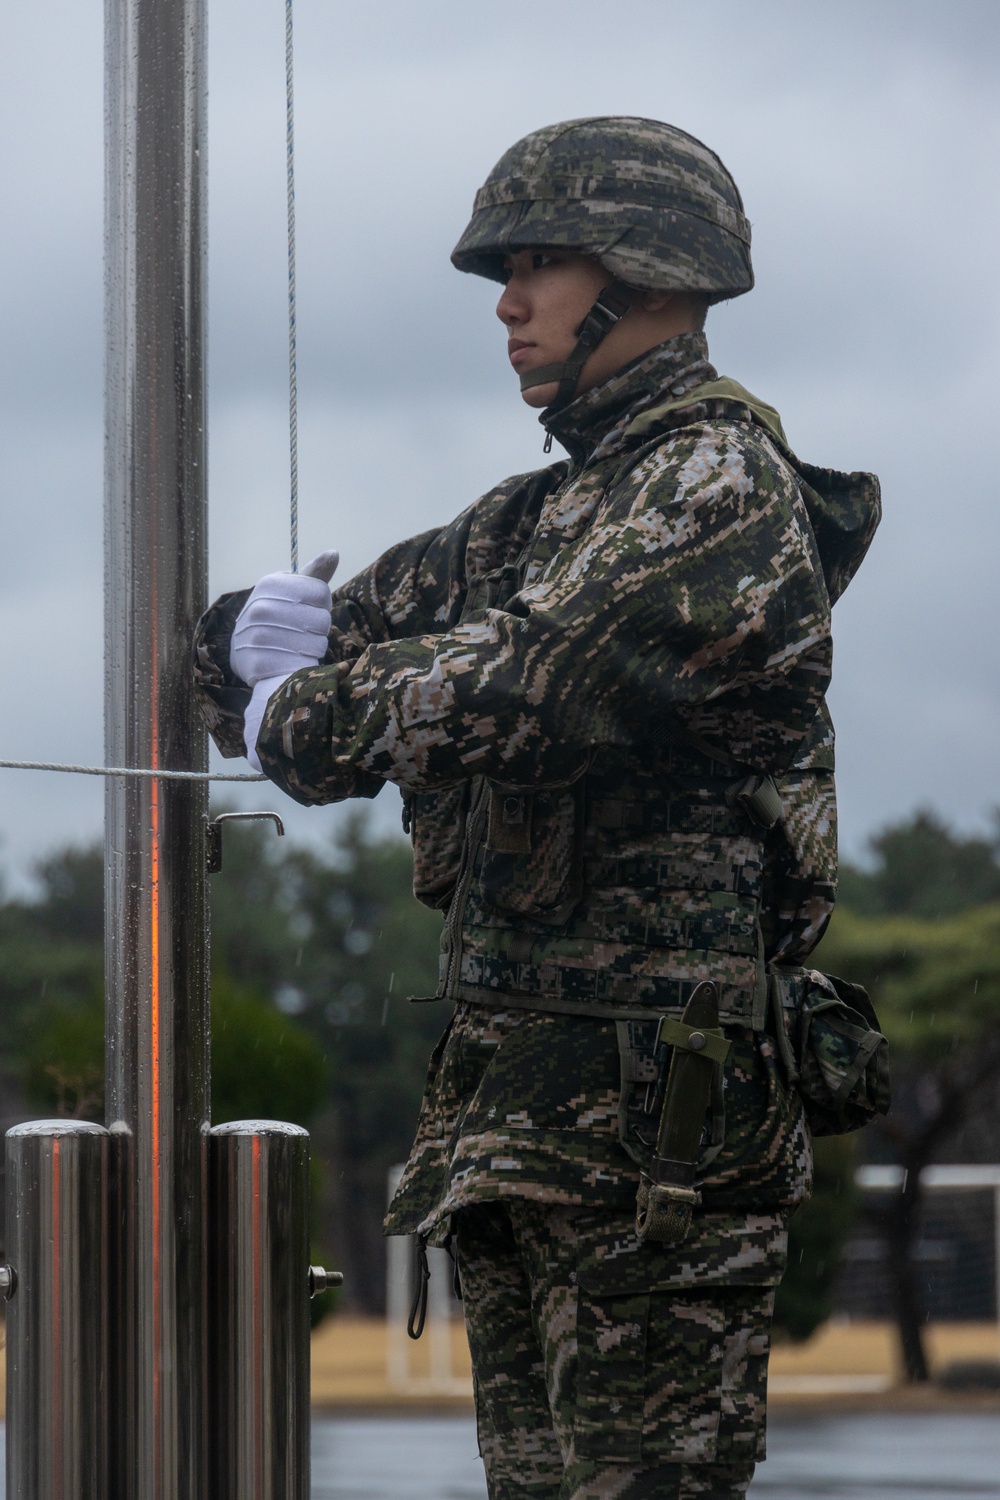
211, 1121, 310, 1500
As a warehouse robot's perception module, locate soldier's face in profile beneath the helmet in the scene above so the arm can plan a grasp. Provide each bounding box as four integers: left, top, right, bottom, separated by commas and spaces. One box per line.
496, 249, 605, 407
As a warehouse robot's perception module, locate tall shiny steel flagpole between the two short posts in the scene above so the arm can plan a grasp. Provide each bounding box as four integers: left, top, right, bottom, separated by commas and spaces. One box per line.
105, 0, 208, 1500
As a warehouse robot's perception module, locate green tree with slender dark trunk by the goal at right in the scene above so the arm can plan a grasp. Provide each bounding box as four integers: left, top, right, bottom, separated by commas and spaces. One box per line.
816, 905, 1000, 1380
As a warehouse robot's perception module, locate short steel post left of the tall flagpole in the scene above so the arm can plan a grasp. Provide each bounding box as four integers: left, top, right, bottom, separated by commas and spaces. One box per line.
4, 1121, 108, 1500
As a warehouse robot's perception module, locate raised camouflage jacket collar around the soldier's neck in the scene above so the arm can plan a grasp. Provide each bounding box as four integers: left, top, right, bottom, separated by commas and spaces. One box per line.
541, 333, 717, 468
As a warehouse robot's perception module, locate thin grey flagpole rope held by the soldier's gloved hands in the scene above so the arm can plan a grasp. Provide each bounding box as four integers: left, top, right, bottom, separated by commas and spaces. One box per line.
0, 0, 298, 782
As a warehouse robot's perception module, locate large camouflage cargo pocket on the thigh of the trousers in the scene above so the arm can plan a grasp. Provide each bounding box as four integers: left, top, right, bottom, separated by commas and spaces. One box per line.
574, 1278, 774, 1464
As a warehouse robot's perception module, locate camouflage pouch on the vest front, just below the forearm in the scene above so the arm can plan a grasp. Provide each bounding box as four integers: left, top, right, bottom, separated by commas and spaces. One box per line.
480, 780, 583, 927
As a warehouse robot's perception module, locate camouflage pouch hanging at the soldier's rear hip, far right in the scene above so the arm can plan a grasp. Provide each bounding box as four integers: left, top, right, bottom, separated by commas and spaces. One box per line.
768, 969, 891, 1136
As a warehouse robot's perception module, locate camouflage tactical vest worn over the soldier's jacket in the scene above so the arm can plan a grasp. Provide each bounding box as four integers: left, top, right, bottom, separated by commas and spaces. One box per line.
405, 380, 868, 1029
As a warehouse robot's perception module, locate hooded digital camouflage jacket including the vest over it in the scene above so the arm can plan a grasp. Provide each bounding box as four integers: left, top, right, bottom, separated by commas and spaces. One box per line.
195, 335, 879, 1281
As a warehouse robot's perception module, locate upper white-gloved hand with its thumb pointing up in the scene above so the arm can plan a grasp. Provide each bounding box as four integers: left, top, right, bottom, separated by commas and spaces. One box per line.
229, 552, 340, 687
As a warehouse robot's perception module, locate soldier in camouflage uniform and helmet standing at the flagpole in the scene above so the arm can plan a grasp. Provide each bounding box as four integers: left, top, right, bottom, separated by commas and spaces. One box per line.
196, 117, 879, 1500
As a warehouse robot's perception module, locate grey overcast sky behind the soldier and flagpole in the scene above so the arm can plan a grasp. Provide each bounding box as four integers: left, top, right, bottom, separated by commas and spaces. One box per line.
0, 0, 1000, 878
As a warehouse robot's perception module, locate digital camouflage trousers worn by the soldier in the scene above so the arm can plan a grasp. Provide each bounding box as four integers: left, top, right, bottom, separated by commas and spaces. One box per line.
453, 1199, 774, 1500
